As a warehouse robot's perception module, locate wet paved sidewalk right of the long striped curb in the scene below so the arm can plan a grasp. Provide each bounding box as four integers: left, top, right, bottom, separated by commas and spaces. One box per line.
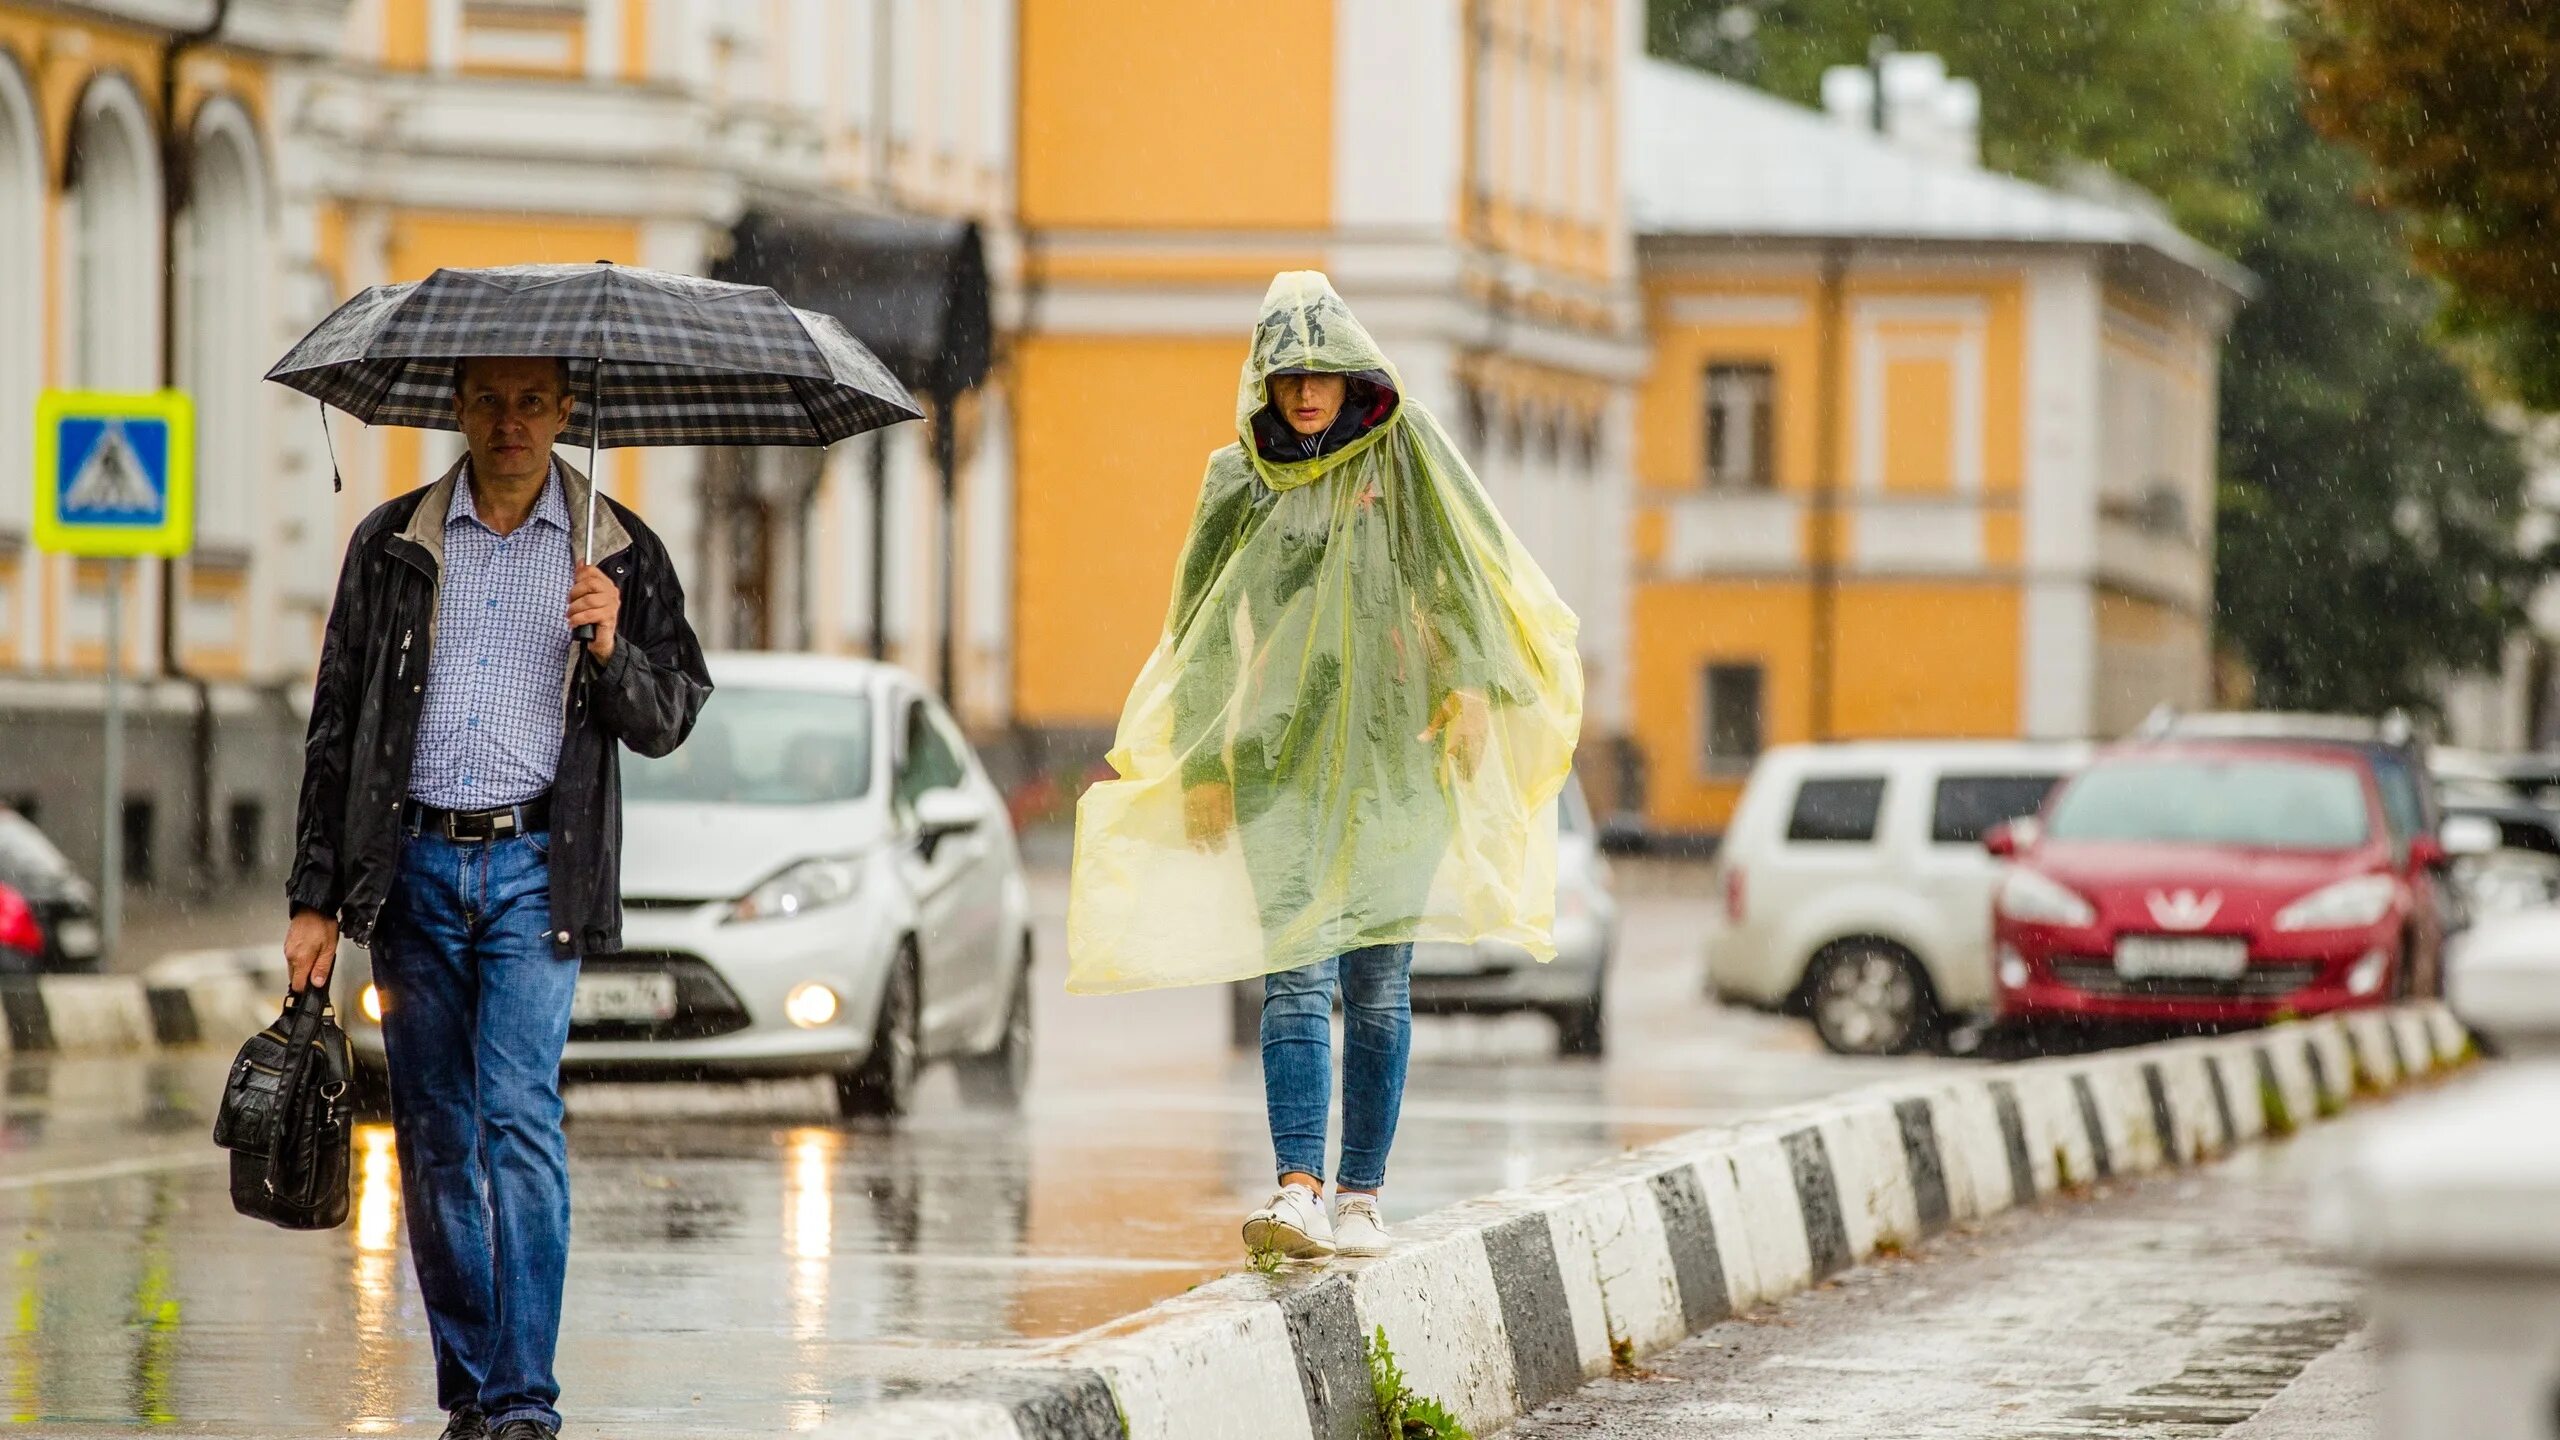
1516, 1101, 2378, 1440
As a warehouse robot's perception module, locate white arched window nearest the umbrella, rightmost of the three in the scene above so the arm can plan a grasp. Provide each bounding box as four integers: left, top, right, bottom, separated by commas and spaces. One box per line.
177, 100, 271, 546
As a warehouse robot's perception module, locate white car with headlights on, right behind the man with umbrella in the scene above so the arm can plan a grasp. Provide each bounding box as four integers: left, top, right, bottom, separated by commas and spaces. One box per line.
333, 653, 1032, 1115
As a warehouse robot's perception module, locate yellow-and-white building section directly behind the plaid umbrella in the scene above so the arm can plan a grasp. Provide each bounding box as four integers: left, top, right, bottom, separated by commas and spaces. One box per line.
297, 0, 1014, 712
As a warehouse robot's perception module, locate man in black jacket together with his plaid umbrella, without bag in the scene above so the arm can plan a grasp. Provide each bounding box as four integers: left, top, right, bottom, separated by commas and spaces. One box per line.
269, 264, 919, 1440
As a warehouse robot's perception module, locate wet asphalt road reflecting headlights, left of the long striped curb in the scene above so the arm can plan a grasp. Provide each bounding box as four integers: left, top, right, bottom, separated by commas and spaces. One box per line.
0, 866, 1953, 1437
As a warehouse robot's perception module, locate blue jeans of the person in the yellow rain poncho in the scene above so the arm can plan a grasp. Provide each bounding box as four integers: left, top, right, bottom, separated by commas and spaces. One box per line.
1262, 945, 1413, 1189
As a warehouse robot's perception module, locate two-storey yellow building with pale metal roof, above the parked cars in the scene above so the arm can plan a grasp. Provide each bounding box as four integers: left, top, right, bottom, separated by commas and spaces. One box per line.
1626, 56, 2245, 833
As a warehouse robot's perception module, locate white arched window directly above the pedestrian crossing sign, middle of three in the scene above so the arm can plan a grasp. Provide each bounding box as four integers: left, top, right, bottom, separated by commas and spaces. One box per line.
61, 77, 161, 389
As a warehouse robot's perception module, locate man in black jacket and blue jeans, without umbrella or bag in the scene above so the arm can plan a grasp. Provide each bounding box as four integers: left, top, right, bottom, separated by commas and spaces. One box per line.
284, 356, 712, 1440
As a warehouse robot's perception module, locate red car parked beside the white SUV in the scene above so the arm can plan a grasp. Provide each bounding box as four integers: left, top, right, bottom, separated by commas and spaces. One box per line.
1984, 740, 2445, 1022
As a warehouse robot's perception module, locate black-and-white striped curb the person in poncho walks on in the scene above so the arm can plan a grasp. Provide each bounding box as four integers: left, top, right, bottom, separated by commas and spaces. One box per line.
860, 1002, 2470, 1440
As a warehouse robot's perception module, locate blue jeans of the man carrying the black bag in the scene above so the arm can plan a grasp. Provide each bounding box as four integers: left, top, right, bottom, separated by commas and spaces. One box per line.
374, 835, 579, 1430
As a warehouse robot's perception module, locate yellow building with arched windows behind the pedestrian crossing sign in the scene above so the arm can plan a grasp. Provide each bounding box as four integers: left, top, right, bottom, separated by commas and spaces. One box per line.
0, 0, 338, 881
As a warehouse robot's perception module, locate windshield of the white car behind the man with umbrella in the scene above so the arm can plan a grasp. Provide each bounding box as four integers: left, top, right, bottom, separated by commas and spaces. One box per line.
622, 687, 870, 805
